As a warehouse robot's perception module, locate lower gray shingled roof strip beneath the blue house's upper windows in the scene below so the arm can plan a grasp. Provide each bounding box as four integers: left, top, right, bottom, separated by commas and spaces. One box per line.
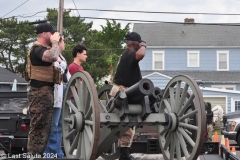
141, 70, 240, 83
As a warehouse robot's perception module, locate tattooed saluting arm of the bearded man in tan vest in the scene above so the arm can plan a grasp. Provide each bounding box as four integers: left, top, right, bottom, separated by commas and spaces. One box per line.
42, 32, 60, 62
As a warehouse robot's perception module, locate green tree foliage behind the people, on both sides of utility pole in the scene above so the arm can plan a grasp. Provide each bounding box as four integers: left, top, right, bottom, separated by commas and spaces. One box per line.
0, 9, 130, 85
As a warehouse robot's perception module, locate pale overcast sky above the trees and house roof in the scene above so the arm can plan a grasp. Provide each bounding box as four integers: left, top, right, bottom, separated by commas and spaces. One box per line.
0, 0, 240, 29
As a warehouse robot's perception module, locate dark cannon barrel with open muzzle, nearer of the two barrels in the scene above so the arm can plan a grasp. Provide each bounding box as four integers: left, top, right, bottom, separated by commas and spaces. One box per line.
125, 79, 154, 104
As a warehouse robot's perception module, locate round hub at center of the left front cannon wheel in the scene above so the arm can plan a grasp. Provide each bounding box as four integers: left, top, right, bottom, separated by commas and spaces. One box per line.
69, 112, 85, 132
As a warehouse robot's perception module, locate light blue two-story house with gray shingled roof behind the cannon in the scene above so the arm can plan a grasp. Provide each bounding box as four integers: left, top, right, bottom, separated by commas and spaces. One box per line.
133, 23, 240, 113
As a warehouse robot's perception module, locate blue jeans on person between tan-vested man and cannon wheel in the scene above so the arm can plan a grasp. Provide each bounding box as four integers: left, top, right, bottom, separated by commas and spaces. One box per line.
44, 107, 64, 158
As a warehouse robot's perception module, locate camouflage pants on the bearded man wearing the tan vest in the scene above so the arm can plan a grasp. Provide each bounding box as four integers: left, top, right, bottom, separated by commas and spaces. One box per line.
27, 89, 53, 156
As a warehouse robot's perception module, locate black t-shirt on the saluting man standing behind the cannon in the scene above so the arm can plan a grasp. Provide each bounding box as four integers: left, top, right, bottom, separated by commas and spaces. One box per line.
114, 49, 142, 87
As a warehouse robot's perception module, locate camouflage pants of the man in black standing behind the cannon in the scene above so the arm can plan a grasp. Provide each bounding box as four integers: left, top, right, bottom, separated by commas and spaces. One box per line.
109, 84, 135, 147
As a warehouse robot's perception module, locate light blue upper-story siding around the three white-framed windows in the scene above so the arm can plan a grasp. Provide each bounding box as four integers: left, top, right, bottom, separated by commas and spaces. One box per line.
139, 48, 240, 71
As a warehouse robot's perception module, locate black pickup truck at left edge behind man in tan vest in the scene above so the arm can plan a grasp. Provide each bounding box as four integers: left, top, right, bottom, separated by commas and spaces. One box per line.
0, 91, 30, 155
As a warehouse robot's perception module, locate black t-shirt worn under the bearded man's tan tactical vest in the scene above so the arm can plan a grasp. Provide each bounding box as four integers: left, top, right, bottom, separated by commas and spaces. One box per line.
30, 46, 54, 88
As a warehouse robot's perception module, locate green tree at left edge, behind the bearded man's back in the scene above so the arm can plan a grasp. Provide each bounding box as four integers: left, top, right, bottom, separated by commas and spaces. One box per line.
0, 18, 35, 75
